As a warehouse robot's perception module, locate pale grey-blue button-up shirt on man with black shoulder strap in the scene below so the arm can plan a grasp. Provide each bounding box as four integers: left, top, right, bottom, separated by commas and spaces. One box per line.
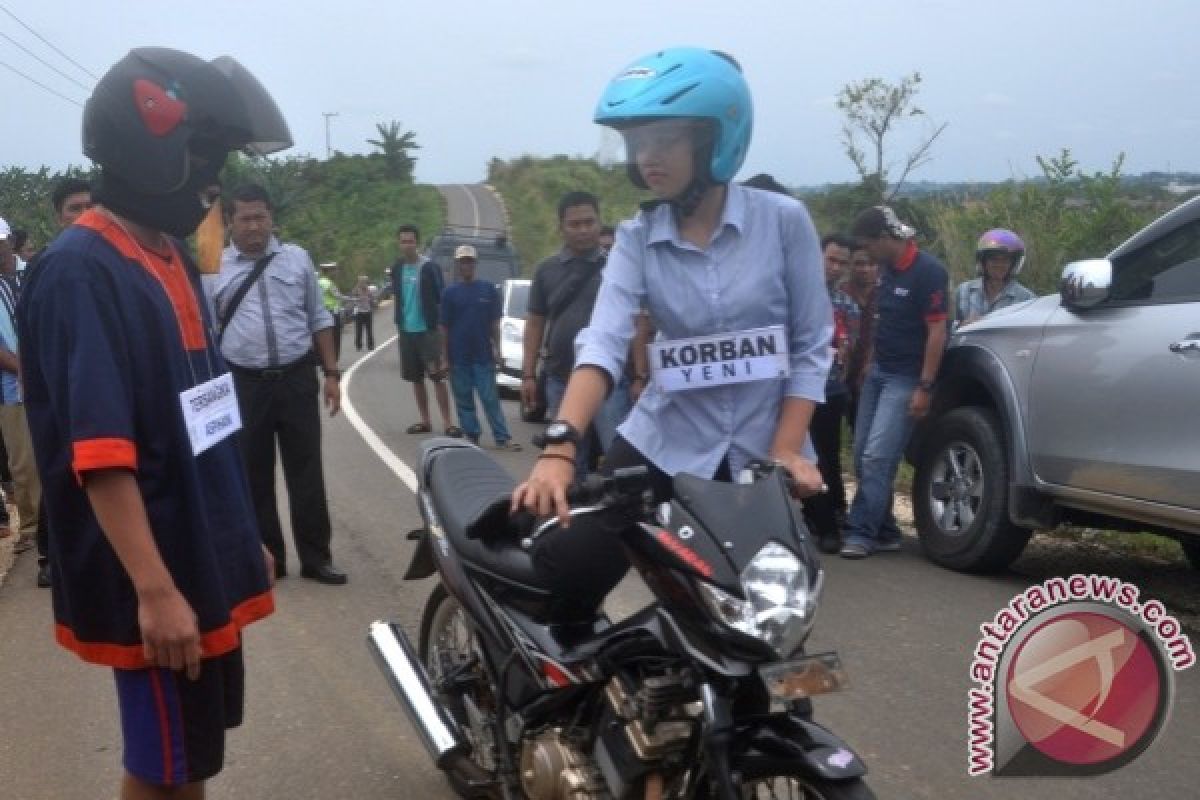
204, 236, 334, 369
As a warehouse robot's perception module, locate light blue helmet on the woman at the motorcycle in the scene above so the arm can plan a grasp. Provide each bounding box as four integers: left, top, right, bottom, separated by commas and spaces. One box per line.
594, 47, 754, 186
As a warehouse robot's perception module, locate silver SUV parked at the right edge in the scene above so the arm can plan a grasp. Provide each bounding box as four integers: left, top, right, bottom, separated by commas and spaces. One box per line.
908, 198, 1200, 572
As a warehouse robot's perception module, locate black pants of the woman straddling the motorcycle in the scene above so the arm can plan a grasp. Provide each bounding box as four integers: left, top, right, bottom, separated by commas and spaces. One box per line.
533, 434, 730, 620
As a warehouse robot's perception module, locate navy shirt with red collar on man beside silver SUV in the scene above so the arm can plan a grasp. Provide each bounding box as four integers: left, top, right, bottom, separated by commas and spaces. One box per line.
875, 241, 949, 377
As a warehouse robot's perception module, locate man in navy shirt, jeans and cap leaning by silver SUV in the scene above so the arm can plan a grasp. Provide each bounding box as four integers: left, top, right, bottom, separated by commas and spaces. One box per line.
841, 206, 949, 559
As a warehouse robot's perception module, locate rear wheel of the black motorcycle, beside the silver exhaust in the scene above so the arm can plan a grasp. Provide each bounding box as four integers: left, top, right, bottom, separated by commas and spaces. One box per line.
420, 584, 502, 800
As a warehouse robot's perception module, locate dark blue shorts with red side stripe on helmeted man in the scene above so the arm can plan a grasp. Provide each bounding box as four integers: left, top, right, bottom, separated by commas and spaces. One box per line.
114, 648, 245, 786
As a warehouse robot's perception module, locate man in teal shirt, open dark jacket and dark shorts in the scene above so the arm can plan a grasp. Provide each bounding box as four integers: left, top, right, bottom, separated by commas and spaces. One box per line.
388, 225, 462, 437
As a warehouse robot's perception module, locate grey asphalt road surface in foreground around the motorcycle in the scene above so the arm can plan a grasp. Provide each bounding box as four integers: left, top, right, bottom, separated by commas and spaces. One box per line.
0, 331, 1200, 800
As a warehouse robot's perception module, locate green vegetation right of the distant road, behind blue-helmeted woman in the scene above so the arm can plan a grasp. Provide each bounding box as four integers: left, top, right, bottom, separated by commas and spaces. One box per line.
488, 150, 1180, 294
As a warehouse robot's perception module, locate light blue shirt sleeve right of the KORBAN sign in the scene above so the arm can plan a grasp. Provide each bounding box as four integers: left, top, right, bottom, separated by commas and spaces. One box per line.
782, 204, 833, 403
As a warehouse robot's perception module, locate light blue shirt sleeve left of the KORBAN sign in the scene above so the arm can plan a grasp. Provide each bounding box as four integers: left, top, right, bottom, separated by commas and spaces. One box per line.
575, 222, 646, 384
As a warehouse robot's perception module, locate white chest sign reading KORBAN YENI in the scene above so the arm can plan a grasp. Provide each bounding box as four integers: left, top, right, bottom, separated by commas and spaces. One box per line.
648, 325, 790, 392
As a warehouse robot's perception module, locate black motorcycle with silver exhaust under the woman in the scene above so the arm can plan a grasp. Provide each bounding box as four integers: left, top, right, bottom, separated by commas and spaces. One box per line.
367, 439, 875, 800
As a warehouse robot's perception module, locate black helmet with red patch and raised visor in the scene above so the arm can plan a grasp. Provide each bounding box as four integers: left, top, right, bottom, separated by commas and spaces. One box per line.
83, 47, 292, 236
